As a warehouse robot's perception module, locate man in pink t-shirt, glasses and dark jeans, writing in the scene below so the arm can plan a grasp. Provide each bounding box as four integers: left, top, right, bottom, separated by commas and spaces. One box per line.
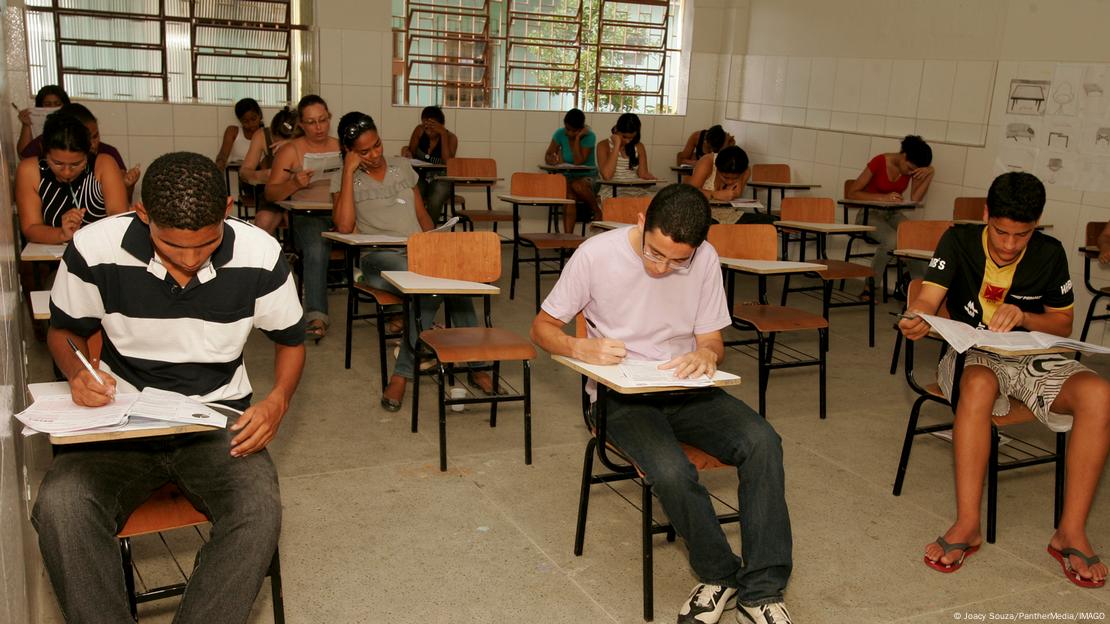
532, 184, 793, 624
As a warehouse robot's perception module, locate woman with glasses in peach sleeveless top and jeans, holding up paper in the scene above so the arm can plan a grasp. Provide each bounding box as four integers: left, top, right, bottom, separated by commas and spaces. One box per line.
265, 94, 340, 342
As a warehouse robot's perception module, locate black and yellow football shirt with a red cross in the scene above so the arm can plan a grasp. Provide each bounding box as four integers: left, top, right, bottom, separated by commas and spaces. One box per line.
925, 224, 1074, 329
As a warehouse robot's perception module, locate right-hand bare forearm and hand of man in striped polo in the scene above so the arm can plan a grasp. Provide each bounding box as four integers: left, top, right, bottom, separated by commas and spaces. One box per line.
231, 343, 304, 457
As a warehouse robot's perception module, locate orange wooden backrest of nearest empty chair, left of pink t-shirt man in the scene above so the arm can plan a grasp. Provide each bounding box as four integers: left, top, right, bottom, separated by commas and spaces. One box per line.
408, 232, 501, 283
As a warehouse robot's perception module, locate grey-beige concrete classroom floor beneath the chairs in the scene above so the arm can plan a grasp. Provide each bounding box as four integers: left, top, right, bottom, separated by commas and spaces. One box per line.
26, 254, 1110, 624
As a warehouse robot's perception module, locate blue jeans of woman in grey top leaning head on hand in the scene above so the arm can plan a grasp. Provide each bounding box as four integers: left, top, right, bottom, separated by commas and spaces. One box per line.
359, 250, 478, 373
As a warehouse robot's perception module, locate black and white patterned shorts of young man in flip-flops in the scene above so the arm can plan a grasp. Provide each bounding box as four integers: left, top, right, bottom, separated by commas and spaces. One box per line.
937, 349, 1090, 432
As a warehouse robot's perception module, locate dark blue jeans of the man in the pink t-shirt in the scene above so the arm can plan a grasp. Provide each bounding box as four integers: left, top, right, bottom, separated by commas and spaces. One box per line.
607, 389, 793, 606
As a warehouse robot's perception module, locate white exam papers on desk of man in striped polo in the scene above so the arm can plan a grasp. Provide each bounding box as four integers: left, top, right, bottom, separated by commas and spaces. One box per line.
16, 388, 228, 435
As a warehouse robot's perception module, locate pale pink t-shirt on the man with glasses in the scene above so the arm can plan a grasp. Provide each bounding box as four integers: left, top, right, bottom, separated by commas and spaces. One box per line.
543, 228, 731, 360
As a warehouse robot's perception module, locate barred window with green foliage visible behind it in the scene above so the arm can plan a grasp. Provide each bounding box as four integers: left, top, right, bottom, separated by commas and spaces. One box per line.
393, 0, 686, 113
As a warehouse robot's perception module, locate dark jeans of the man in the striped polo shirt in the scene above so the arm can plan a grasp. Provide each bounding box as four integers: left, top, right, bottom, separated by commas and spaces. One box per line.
31, 430, 281, 624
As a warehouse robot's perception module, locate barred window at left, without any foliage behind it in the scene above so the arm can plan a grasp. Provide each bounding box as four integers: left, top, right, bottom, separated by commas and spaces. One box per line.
26, 0, 313, 105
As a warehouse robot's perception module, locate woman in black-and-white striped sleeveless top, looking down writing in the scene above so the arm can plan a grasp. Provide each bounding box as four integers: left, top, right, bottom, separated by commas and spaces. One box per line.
16, 112, 128, 244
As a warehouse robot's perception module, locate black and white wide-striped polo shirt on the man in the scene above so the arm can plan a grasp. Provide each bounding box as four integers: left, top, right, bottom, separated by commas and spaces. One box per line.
50, 212, 304, 410
